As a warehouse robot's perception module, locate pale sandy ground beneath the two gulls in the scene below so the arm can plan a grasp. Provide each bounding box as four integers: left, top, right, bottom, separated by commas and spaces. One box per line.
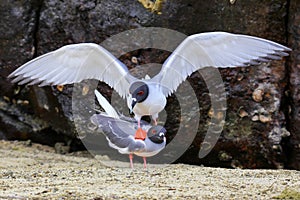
0, 141, 300, 199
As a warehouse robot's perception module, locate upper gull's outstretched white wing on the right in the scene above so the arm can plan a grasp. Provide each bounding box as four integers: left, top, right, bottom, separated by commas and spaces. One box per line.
152, 32, 291, 96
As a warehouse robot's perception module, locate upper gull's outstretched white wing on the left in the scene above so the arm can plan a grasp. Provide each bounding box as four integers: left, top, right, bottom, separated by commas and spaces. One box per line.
9, 43, 135, 97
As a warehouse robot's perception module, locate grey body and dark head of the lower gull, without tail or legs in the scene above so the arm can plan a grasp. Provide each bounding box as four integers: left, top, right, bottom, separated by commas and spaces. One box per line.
91, 114, 166, 157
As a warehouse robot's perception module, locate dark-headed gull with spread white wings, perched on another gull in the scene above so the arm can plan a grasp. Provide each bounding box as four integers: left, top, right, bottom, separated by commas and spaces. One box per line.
9, 32, 291, 139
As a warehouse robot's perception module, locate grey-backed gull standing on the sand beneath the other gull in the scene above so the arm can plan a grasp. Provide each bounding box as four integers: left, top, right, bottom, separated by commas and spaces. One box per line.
91, 90, 167, 168
